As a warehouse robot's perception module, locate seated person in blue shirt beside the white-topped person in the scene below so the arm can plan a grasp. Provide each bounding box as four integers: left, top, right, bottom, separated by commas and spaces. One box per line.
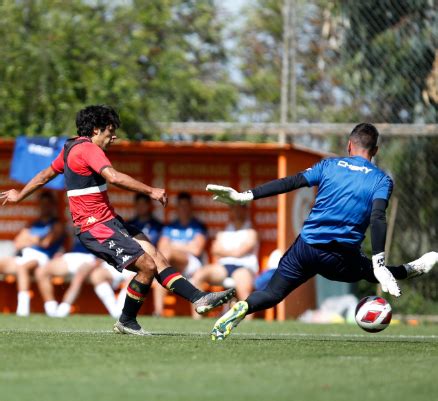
154, 192, 207, 316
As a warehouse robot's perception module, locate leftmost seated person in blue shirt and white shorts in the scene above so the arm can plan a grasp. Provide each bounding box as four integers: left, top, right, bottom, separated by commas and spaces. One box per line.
0, 192, 64, 316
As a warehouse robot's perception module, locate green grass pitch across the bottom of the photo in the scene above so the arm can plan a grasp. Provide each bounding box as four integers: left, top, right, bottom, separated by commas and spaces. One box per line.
0, 315, 438, 401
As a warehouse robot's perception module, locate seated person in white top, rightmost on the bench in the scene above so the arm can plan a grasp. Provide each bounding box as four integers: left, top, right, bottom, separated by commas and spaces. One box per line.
192, 205, 259, 317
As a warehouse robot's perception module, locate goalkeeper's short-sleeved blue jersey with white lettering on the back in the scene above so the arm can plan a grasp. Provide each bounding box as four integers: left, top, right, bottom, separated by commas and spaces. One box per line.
301, 156, 393, 247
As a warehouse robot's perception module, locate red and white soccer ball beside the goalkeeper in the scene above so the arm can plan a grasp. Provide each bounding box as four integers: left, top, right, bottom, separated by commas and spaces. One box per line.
355, 296, 392, 333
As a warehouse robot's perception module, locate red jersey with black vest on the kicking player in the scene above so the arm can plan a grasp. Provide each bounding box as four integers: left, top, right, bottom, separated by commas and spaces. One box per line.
52, 137, 116, 232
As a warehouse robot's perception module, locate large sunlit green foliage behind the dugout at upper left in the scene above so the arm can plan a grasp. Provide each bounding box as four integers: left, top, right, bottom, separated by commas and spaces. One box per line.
0, 0, 236, 138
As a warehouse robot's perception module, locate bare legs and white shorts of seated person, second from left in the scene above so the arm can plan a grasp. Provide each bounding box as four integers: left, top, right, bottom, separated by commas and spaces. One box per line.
35, 236, 101, 317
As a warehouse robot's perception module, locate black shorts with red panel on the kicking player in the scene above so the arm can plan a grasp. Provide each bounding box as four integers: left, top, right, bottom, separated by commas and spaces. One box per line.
78, 216, 144, 272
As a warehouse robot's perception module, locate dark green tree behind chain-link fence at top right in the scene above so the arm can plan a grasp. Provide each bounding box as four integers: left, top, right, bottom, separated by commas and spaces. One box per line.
338, 0, 438, 123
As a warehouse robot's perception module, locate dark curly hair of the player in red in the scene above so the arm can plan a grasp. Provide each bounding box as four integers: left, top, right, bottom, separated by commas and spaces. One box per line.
76, 105, 120, 137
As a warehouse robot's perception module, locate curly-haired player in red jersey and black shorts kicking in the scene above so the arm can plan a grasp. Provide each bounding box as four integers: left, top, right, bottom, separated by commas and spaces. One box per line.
0, 105, 235, 335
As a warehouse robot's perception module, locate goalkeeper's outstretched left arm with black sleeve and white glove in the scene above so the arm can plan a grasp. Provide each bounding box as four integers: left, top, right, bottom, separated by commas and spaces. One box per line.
206, 173, 310, 204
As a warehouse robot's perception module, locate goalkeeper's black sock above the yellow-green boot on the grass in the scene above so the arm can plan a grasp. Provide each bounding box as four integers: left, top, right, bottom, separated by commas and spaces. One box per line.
246, 271, 294, 314
